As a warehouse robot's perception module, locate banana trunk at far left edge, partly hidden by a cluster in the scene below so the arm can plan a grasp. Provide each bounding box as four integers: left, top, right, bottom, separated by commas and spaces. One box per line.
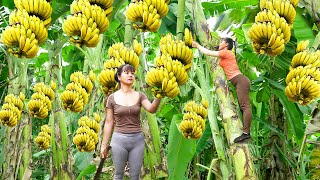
1, 56, 32, 179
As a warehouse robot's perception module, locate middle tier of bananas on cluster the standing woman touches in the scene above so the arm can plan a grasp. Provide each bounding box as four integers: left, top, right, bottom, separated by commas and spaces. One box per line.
154, 54, 188, 85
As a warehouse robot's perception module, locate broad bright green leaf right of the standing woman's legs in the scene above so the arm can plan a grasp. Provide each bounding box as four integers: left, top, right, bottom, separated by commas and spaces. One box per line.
168, 114, 196, 180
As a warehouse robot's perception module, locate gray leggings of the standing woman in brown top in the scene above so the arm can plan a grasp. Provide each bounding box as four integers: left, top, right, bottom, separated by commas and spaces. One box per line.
110, 132, 144, 180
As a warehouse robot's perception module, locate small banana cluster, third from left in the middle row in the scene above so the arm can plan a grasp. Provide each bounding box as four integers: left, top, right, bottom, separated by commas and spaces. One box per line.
60, 71, 96, 112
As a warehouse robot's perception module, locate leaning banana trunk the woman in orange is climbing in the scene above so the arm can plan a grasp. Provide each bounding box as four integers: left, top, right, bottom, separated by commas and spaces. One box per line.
193, 0, 258, 179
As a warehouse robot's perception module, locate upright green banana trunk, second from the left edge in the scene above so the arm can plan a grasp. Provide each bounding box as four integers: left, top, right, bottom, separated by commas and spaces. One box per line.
46, 37, 73, 180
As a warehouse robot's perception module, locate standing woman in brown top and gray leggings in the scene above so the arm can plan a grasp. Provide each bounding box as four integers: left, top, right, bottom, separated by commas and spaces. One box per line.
101, 64, 160, 180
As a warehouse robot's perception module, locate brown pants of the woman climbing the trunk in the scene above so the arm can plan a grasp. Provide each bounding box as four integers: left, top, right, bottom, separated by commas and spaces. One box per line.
230, 74, 252, 134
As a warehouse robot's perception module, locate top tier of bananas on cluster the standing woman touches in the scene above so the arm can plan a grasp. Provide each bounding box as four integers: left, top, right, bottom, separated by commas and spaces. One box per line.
160, 35, 193, 65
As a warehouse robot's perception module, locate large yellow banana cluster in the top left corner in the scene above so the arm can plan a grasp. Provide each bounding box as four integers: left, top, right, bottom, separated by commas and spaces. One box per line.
1, 0, 52, 58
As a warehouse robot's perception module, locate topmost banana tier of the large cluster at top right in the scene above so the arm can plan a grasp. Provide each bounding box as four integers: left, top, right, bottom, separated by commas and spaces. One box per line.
260, 0, 296, 27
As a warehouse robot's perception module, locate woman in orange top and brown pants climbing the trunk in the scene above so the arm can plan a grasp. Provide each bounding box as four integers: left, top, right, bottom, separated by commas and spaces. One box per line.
192, 38, 252, 143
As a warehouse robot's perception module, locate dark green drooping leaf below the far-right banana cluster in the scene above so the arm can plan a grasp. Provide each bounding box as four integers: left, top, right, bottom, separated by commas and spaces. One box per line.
272, 89, 305, 141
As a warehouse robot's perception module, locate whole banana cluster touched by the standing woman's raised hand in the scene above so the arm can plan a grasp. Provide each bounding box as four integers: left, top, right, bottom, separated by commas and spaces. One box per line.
146, 28, 193, 98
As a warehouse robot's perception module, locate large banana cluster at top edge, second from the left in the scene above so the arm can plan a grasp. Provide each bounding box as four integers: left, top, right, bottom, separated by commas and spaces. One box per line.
62, 0, 113, 47
